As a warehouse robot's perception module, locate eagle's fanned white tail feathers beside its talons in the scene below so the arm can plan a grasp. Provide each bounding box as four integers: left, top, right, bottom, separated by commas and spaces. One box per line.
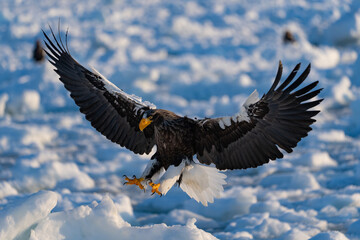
180, 163, 226, 206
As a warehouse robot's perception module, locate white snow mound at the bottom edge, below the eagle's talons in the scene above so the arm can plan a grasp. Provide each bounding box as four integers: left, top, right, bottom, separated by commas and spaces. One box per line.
30, 196, 216, 240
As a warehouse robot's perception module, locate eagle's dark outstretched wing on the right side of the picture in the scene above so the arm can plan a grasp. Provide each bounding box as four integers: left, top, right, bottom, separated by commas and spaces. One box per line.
196, 62, 322, 169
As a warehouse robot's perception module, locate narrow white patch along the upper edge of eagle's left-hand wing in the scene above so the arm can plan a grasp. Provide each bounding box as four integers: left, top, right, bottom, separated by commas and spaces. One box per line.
90, 66, 156, 109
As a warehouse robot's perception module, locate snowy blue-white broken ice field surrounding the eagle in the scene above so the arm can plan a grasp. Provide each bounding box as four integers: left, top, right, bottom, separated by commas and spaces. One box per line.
0, 0, 360, 240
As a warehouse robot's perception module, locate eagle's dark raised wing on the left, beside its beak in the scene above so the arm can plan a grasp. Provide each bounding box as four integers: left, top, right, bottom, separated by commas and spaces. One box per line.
43, 28, 155, 154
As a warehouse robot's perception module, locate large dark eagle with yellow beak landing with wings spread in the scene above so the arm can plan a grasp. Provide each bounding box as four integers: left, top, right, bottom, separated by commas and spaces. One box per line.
43, 27, 323, 206
